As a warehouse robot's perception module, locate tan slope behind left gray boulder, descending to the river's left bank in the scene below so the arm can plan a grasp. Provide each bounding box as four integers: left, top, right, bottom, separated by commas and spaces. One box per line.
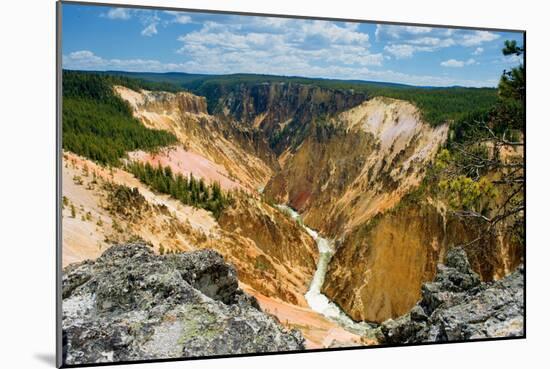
62, 152, 360, 348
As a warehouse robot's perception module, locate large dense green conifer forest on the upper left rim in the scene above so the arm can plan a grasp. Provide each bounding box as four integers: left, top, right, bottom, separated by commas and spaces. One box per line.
62, 71, 176, 165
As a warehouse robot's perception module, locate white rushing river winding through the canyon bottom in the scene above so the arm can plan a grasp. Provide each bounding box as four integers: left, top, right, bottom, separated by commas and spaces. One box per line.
277, 205, 372, 335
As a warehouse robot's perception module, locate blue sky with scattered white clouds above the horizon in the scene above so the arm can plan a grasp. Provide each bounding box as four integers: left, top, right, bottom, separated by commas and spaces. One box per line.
62, 4, 523, 87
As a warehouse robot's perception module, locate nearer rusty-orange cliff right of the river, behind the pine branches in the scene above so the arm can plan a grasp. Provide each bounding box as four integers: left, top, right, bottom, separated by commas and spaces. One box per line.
323, 197, 523, 323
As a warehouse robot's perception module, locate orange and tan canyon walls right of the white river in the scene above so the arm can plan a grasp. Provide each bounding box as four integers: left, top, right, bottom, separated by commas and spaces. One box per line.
265, 98, 521, 322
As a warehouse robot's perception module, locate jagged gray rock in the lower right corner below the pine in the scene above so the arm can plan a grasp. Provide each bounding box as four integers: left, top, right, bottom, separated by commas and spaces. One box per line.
379, 248, 524, 344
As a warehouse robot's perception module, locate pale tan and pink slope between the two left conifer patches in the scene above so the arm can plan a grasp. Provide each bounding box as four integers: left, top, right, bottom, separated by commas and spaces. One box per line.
115, 86, 272, 190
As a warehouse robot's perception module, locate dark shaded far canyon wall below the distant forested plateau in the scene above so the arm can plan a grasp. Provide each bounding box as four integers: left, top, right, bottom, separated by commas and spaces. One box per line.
211, 82, 367, 155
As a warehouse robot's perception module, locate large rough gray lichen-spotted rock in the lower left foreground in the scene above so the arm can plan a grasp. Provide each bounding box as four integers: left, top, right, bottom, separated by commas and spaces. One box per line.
62, 244, 310, 365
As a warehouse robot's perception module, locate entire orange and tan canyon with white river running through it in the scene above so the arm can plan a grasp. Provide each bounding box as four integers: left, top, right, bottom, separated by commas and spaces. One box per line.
62, 82, 523, 355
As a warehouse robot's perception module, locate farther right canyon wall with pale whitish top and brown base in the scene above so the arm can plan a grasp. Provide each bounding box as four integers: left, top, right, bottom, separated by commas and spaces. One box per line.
265, 98, 448, 231
